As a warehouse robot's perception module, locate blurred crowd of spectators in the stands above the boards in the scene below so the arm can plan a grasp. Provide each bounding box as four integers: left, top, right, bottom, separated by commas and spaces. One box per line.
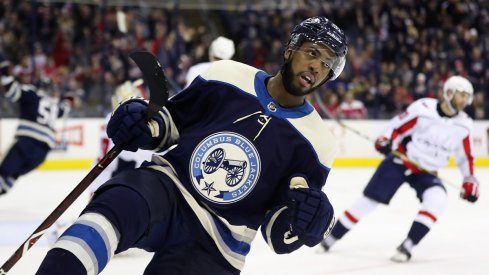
0, 0, 489, 119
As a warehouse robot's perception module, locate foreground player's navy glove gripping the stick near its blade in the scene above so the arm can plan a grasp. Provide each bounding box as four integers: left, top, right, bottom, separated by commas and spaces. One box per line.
107, 99, 165, 152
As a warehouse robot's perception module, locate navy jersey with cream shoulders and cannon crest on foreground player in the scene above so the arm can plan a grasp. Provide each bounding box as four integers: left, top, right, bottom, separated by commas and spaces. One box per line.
147, 60, 336, 269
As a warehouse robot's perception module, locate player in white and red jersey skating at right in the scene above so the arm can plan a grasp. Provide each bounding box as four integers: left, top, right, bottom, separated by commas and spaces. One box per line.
321, 76, 479, 262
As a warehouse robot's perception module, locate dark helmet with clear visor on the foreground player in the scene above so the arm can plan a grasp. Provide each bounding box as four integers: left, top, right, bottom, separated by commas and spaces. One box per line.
288, 16, 348, 80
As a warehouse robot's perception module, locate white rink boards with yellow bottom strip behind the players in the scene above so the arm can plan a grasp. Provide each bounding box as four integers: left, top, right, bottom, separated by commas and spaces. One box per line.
0, 118, 489, 170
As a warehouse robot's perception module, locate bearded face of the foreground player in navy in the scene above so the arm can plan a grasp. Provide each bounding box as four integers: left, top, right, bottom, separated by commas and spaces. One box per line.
282, 42, 335, 96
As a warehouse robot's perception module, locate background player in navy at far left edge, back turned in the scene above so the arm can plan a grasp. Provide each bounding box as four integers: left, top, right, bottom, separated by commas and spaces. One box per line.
0, 60, 73, 195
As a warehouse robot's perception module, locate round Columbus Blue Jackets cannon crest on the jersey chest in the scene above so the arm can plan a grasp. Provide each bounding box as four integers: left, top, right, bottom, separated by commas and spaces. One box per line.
190, 132, 260, 204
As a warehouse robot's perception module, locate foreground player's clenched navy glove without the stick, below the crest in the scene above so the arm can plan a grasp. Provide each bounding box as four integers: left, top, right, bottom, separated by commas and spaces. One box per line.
289, 183, 334, 247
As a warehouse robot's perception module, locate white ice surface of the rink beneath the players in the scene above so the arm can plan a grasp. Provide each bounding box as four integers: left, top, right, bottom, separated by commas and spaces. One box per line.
0, 168, 489, 275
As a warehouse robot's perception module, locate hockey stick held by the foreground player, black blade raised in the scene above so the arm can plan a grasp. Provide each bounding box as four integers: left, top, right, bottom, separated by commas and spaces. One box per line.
0, 51, 168, 275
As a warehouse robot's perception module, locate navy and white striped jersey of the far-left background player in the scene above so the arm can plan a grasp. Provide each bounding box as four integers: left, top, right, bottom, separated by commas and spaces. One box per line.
5, 81, 70, 148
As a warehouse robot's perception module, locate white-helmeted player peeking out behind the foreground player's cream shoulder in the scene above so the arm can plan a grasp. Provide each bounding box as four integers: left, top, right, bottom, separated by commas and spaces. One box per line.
185, 36, 235, 88
